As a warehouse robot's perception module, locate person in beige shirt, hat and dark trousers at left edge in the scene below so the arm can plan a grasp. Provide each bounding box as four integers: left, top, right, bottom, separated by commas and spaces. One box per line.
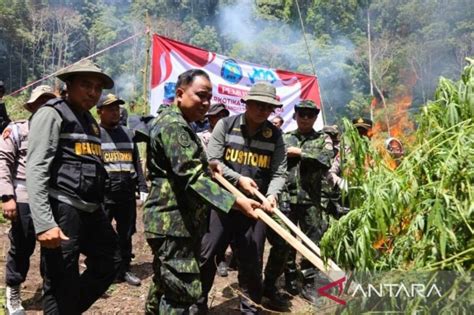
0, 85, 56, 314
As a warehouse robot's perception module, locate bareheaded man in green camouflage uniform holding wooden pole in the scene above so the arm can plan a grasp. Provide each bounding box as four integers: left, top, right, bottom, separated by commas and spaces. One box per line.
143, 69, 260, 314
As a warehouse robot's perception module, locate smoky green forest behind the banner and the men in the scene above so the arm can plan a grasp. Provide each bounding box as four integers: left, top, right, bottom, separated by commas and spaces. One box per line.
0, 0, 474, 128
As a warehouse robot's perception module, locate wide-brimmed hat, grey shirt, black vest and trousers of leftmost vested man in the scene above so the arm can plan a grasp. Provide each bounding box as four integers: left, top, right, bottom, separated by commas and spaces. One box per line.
26, 61, 121, 314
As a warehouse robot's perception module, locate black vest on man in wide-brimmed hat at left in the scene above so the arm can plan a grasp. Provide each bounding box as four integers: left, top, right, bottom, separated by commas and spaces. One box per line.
45, 99, 106, 203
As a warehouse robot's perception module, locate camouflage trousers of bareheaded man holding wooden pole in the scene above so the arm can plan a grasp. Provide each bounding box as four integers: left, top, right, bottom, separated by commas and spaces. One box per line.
145, 235, 202, 314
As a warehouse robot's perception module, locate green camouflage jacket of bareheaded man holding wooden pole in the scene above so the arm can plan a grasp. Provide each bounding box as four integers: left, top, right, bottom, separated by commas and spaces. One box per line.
143, 105, 235, 238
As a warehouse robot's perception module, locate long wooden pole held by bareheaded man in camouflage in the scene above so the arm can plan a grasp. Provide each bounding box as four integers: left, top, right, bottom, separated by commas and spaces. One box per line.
214, 173, 344, 281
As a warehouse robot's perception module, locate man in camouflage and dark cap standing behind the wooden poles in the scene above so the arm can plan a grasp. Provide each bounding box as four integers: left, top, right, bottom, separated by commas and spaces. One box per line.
265, 100, 334, 304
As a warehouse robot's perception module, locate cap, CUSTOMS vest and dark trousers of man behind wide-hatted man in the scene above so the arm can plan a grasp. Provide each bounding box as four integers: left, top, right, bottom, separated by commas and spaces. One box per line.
97, 94, 148, 285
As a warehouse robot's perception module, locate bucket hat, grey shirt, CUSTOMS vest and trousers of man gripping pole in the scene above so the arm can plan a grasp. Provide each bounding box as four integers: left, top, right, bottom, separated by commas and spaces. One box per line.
200, 83, 286, 313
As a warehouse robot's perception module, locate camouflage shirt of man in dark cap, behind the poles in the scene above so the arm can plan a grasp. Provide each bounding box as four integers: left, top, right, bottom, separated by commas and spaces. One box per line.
283, 130, 334, 204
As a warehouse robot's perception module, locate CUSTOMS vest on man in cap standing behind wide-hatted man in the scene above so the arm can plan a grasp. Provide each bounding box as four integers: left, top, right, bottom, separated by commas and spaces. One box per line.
100, 125, 138, 203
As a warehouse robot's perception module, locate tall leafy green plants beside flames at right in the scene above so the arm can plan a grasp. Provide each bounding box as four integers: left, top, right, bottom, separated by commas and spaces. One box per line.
322, 59, 474, 271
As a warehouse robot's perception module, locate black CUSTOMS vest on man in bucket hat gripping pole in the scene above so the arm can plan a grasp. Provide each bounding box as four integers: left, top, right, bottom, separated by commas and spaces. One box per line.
223, 114, 281, 194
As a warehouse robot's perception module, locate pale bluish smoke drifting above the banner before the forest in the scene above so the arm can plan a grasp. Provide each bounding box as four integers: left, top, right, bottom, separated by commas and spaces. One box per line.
217, 0, 355, 122
